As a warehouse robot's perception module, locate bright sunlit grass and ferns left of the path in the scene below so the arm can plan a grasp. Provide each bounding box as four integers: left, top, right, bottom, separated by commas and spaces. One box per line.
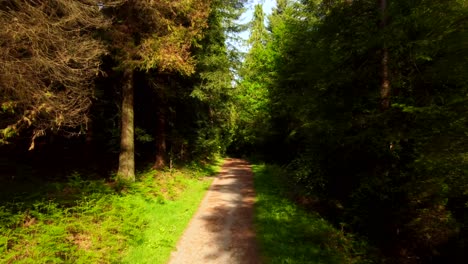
0, 160, 220, 263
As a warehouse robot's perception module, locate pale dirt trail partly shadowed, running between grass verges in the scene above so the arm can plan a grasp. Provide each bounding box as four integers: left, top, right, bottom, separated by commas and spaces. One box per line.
169, 159, 260, 264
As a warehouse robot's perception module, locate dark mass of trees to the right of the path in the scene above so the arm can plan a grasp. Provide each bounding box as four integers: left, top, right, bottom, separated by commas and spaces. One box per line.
238, 0, 468, 263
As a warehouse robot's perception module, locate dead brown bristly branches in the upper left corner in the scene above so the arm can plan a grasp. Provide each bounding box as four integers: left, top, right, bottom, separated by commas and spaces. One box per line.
0, 0, 108, 146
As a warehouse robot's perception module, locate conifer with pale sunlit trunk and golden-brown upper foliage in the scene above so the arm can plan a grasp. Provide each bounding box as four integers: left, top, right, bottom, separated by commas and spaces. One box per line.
105, 0, 209, 181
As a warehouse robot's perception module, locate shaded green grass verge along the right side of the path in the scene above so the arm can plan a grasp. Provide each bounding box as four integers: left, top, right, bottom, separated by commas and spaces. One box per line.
253, 165, 373, 264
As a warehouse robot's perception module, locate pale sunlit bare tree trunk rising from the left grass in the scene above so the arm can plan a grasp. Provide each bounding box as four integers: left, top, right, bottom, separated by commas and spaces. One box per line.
117, 70, 135, 181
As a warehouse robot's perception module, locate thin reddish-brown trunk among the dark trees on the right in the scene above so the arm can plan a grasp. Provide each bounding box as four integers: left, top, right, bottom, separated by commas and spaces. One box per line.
380, 0, 391, 111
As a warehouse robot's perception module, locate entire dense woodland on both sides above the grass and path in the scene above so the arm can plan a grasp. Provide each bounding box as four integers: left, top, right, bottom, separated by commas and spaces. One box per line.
0, 0, 468, 263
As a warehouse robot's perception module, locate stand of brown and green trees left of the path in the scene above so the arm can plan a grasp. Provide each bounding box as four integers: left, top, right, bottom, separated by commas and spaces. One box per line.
0, 0, 244, 181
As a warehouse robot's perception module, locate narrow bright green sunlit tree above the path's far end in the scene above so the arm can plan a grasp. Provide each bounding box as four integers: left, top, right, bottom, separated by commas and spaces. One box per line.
231, 4, 273, 154
